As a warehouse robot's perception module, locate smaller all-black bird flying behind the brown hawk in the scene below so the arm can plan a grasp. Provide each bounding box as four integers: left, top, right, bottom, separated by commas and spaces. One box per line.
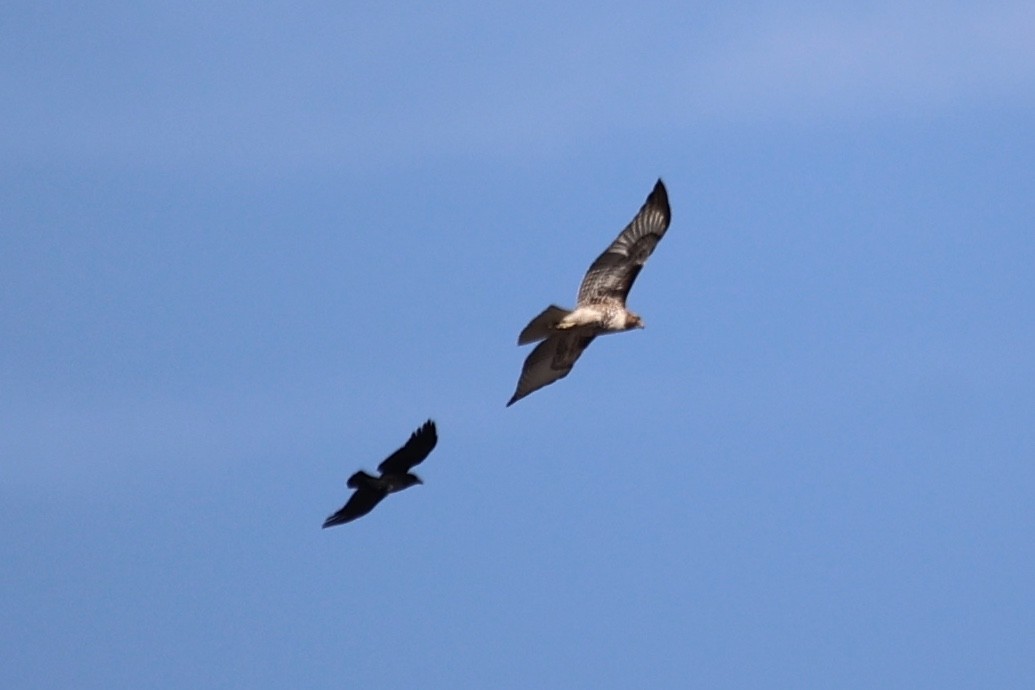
324, 419, 439, 528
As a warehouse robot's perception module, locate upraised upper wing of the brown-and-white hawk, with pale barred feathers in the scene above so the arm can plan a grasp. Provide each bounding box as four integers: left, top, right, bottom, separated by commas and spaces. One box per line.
579, 180, 672, 306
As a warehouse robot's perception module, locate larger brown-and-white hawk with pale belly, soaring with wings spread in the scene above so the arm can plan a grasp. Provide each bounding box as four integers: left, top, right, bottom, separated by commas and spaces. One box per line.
507, 180, 672, 408
